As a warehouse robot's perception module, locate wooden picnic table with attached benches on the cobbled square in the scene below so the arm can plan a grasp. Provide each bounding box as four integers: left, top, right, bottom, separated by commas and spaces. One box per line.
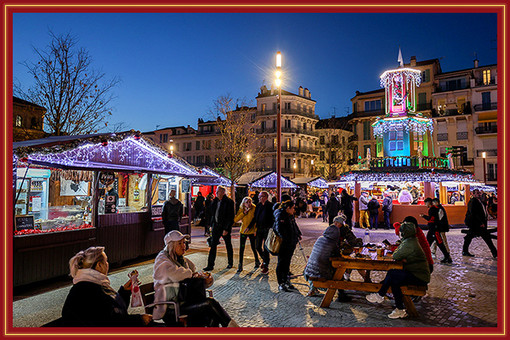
311, 256, 427, 316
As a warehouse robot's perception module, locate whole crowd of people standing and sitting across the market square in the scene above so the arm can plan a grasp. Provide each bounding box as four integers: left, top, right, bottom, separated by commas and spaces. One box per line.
58, 186, 497, 327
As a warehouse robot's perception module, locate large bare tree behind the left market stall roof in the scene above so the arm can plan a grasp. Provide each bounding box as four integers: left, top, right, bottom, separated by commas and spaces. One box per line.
14, 31, 119, 136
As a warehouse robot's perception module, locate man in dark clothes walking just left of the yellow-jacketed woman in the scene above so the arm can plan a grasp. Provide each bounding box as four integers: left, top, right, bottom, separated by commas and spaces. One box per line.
204, 186, 235, 271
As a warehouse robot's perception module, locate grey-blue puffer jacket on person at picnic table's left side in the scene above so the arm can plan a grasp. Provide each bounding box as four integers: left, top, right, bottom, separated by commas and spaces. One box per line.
304, 225, 340, 280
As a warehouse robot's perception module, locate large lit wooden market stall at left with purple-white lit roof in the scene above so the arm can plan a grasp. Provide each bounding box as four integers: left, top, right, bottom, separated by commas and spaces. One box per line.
13, 131, 207, 286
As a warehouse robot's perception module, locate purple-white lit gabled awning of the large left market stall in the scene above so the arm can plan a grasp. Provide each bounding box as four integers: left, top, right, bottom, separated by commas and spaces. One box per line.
13, 131, 210, 178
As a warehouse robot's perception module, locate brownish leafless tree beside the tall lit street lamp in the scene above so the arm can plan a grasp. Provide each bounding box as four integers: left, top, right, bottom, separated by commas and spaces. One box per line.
210, 94, 262, 201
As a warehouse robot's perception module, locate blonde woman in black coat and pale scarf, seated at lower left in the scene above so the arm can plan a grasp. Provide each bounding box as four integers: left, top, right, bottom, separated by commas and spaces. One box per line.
62, 247, 152, 327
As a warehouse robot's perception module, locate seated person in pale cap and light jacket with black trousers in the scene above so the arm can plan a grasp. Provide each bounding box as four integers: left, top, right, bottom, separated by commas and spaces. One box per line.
153, 230, 238, 327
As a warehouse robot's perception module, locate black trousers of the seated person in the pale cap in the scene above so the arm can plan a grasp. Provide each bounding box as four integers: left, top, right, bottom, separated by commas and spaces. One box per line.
163, 298, 232, 327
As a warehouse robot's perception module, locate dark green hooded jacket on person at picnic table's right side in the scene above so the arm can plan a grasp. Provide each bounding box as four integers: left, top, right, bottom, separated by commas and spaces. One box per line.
393, 223, 430, 283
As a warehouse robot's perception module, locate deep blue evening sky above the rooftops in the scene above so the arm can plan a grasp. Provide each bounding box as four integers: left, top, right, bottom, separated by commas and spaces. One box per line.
13, 13, 497, 131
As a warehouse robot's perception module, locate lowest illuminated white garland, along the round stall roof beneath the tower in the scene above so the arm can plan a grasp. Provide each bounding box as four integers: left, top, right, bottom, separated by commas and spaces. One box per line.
339, 169, 479, 183
